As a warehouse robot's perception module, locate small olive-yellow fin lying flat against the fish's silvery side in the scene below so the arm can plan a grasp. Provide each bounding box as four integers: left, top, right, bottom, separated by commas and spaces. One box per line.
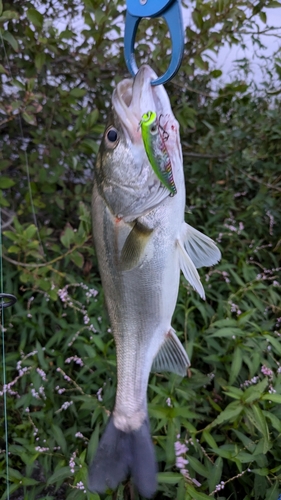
120, 222, 153, 271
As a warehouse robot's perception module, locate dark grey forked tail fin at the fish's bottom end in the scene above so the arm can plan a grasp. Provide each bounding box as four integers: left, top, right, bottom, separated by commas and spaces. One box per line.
88, 418, 157, 498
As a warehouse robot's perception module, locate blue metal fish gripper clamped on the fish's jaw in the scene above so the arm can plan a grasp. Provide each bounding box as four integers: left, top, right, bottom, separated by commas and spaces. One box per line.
124, 0, 184, 85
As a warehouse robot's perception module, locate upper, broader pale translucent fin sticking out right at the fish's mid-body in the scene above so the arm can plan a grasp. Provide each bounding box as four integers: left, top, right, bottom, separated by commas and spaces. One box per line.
182, 223, 221, 268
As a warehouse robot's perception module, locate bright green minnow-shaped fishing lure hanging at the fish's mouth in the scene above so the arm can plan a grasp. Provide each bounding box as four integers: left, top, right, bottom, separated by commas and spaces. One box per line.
140, 111, 177, 196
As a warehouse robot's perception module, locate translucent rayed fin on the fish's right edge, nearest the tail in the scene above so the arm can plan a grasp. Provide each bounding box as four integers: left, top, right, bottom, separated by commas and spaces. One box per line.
151, 327, 190, 377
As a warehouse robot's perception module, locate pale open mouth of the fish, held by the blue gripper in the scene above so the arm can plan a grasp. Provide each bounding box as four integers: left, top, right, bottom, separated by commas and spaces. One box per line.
112, 64, 173, 143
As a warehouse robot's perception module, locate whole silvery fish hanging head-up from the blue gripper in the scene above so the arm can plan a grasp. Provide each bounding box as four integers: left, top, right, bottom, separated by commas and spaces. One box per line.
88, 65, 221, 498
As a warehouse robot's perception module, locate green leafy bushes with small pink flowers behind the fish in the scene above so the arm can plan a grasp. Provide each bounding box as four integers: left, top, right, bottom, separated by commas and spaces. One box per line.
0, 0, 281, 500
